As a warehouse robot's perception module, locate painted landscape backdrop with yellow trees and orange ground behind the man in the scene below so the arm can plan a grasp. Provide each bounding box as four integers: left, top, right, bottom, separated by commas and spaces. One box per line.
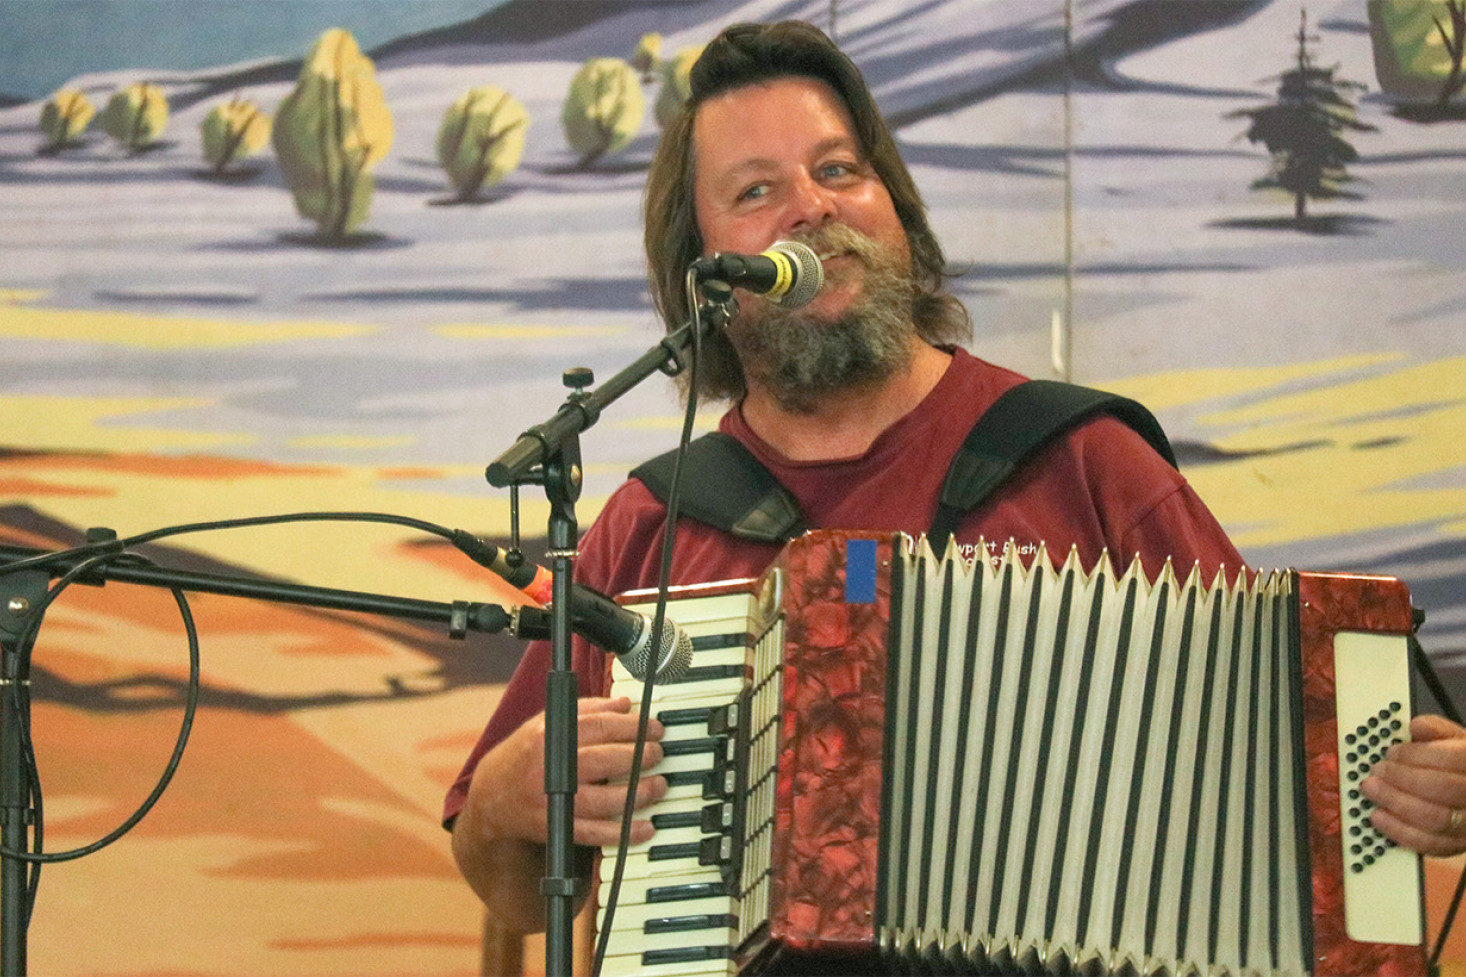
0, 0, 1466, 977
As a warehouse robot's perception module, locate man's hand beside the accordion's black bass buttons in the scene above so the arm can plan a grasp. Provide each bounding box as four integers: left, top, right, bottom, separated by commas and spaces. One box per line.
1359, 716, 1466, 855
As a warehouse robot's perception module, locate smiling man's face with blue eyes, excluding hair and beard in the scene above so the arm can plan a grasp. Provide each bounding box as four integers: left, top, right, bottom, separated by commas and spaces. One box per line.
692, 78, 910, 318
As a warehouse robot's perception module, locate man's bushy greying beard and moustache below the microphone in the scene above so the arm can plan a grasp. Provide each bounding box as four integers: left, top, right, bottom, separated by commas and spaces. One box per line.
727, 233, 916, 414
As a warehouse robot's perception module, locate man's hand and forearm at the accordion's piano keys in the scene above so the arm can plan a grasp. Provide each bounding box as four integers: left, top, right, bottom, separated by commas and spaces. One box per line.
453, 698, 667, 932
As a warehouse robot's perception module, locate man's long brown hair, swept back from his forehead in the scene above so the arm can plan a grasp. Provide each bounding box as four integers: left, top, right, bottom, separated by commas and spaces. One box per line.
645, 21, 972, 399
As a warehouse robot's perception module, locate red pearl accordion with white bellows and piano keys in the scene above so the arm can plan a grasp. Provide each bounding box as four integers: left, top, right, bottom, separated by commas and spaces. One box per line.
597, 533, 1425, 977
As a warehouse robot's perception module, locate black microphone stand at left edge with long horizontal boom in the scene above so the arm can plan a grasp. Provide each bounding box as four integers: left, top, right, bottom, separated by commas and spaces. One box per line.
0, 542, 513, 977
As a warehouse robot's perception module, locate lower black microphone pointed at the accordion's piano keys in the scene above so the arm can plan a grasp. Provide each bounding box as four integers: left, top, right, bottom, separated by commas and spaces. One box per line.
453, 530, 692, 682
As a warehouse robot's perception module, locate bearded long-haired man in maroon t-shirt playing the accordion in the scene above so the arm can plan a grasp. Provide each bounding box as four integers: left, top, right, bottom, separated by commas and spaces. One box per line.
444, 22, 1466, 930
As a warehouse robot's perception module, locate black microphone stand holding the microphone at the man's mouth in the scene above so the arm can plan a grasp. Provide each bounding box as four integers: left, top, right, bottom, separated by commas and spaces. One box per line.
484, 288, 736, 977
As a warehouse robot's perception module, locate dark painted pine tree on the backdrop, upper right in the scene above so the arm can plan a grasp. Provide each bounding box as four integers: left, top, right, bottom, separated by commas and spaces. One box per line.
1229, 12, 1375, 224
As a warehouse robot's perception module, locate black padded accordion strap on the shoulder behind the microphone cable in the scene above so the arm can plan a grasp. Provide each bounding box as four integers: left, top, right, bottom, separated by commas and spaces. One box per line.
632, 431, 805, 543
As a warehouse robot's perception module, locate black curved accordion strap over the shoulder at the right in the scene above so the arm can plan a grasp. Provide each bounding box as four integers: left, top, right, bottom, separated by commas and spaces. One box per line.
928, 380, 1176, 552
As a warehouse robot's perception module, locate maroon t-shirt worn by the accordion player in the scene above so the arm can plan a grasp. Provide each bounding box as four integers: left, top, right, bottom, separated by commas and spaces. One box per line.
444, 349, 1242, 822
